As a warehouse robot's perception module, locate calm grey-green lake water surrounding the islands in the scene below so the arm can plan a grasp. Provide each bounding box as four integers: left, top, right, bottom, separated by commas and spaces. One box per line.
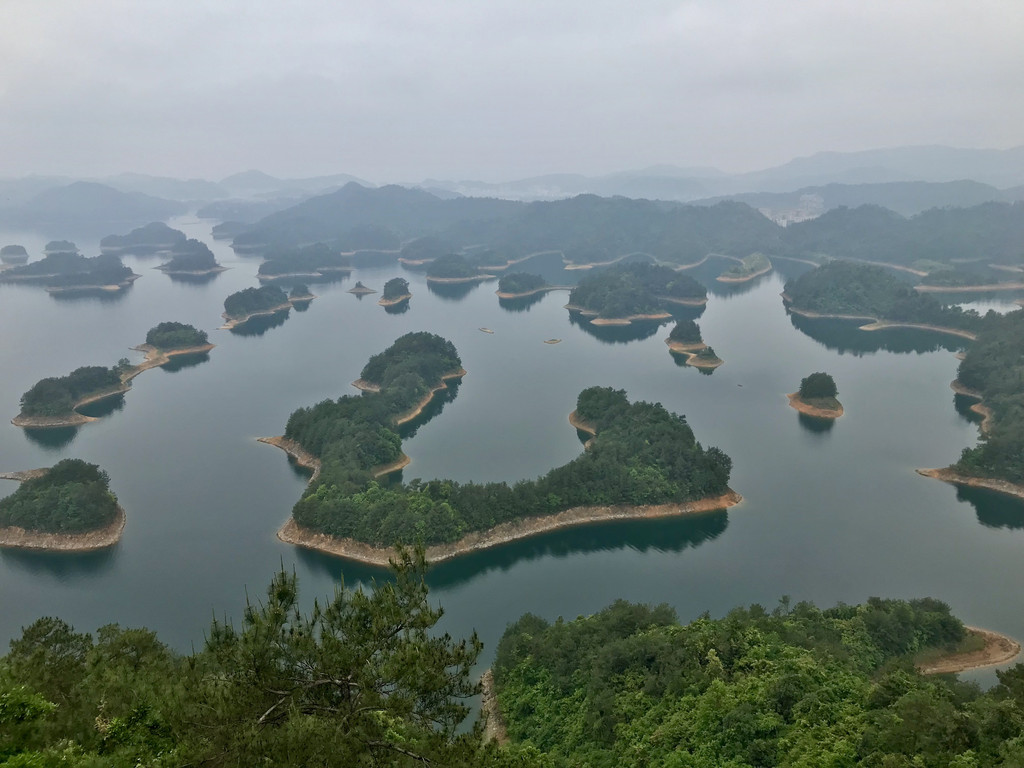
0, 217, 1024, 682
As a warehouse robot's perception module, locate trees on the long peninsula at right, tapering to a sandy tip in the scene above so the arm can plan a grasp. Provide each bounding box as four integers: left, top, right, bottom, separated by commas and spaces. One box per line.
785, 261, 983, 331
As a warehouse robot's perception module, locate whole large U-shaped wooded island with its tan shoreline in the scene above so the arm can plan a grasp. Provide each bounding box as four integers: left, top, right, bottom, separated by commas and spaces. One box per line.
264, 332, 740, 564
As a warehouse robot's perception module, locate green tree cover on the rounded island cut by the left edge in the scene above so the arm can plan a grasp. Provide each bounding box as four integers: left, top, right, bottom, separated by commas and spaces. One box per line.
0, 459, 118, 534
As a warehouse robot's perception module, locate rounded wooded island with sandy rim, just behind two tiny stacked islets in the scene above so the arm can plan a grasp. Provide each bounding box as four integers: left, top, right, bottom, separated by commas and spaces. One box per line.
566, 261, 708, 326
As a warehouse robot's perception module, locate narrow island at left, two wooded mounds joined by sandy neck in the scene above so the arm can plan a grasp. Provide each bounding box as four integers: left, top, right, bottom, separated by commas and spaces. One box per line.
11, 323, 213, 429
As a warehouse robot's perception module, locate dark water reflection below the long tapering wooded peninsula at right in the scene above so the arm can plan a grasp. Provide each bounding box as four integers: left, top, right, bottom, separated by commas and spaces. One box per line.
788, 312, 967, 357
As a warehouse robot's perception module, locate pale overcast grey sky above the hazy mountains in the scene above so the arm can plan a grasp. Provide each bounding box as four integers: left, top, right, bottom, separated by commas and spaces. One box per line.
0, 0, 1024, 183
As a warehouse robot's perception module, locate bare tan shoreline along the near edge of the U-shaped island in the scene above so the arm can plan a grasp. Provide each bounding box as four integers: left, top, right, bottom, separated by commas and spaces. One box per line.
278, 490, 742, 567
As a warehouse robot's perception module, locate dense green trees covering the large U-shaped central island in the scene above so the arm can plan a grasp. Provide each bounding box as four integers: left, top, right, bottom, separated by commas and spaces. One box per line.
285, 352, 732, 545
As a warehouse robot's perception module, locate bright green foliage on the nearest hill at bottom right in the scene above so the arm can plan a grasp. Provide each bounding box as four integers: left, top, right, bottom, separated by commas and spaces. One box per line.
494, 598, 1024, 768
